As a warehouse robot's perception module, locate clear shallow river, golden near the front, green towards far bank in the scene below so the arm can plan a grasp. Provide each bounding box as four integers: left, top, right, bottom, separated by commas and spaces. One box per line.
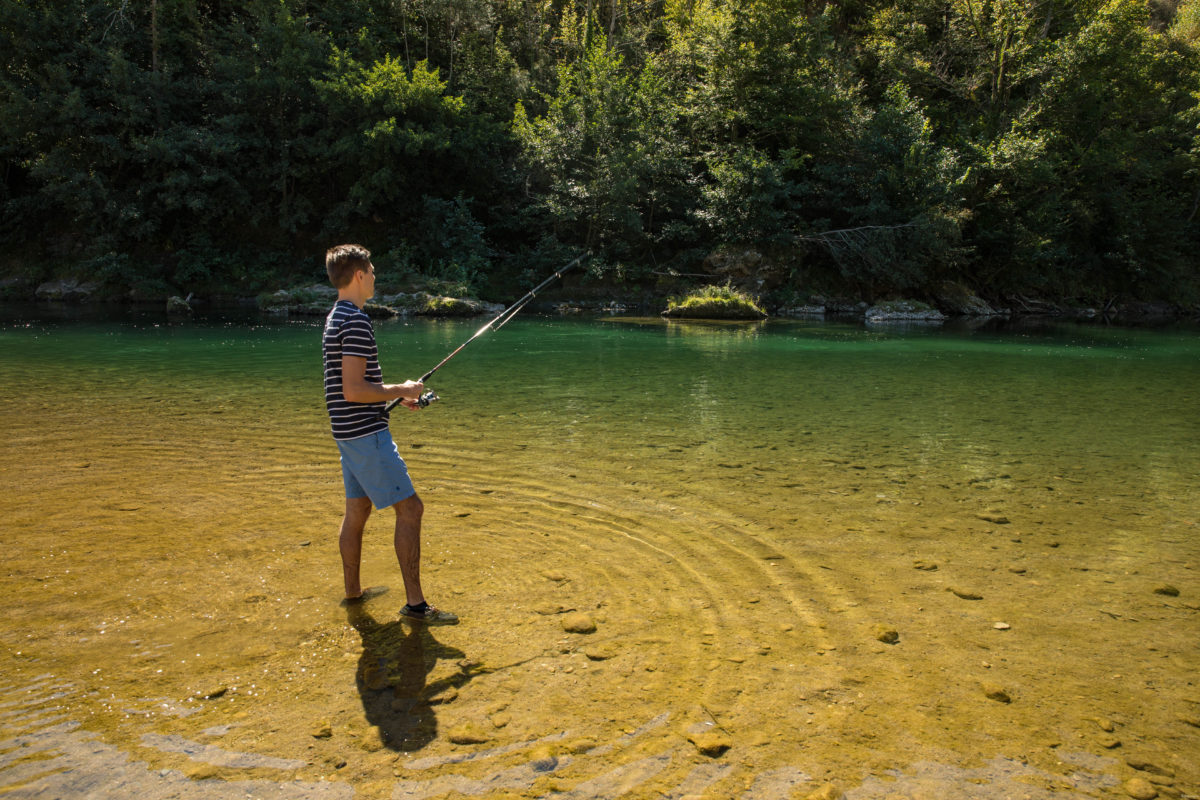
0, 314, 1200, 800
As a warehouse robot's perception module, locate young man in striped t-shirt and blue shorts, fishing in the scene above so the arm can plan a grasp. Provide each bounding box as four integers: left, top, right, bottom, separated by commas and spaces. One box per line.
322, 245, 458, 625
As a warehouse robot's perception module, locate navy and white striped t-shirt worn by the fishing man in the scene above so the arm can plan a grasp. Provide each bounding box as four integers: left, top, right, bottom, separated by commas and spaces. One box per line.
322, 300, 388, 439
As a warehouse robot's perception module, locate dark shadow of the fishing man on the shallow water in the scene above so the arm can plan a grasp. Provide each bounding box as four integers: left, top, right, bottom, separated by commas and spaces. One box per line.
346, 604, 485, 752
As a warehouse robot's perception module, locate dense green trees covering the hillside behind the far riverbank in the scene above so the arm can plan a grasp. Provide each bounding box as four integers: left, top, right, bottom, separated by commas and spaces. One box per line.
0, 0, 1200, 302
